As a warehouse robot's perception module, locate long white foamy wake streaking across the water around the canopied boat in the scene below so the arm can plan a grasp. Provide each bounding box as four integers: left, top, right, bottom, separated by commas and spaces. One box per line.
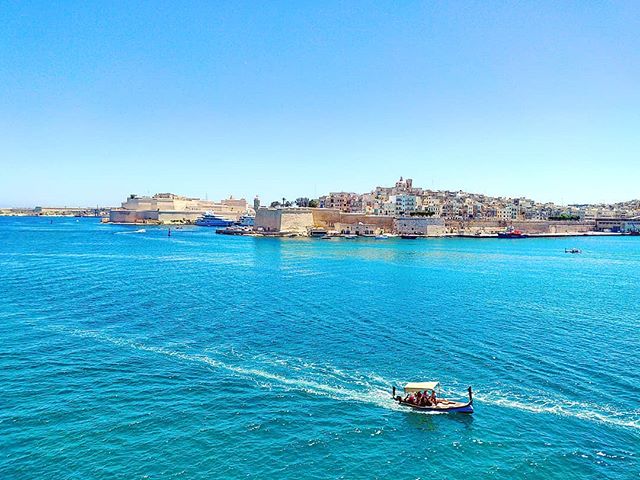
49, 326, 640, 430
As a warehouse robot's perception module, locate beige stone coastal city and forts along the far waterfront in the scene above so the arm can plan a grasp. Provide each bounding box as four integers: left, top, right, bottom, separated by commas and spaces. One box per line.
0, 177, 640, 239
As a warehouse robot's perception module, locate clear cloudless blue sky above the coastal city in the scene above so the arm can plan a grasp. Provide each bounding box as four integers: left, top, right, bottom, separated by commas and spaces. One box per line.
0, 0, 640, 206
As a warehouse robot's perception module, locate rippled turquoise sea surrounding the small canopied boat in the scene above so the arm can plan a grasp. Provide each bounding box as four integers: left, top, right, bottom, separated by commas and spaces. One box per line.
0, 218, 640, 479
